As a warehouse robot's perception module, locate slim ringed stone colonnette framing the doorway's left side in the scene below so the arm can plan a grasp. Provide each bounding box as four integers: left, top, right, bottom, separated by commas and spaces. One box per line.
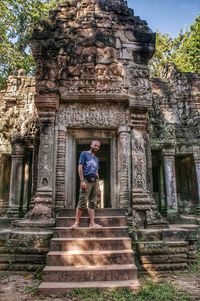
55, 126, 67, 208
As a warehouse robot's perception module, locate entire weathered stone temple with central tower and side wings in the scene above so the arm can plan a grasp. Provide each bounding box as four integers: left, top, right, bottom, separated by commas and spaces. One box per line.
0, 0, 200, 290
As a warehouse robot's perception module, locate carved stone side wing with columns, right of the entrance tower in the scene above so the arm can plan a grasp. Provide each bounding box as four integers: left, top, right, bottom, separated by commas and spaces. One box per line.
148, 64, 200, 213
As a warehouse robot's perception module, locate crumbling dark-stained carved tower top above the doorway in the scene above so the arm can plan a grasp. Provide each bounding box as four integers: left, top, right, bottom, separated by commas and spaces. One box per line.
31, 0, 155, 100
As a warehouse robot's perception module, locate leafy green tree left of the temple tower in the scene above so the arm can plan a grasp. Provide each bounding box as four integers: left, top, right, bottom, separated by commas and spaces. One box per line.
0, 0, 56, 87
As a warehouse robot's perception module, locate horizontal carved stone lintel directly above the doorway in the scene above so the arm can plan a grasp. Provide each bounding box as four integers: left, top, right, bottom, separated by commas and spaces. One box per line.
57, 104, 129, 128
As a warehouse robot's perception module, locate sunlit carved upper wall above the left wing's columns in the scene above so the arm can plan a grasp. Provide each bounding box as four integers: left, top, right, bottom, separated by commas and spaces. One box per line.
0, 69, 37, 152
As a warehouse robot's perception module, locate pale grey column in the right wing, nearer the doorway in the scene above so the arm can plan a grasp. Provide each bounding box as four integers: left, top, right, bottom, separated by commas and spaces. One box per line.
162, 148, 178, 217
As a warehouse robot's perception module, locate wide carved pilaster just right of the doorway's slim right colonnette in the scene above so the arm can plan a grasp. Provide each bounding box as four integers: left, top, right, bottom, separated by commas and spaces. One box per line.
131, 113, 150, 226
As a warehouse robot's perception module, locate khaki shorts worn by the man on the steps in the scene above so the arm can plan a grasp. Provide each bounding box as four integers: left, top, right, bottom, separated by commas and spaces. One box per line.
77, 179, 99, 209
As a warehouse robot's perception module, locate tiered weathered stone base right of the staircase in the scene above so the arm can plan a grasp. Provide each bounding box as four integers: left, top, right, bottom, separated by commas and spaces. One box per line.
133, 224, 200, 273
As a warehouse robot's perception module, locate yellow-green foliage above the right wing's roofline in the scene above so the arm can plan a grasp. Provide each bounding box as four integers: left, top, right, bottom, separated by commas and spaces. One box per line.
149, 16, 200, 77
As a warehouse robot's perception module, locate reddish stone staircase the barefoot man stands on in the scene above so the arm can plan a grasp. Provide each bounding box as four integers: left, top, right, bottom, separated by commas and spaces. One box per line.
39, 209, 139, 294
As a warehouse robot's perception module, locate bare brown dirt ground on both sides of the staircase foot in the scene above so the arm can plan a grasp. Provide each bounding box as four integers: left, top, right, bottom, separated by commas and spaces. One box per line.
0, 272, 200, 301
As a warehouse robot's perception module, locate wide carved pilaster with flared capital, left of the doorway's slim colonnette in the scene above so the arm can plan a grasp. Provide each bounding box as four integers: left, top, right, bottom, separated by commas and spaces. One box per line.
29, 93, 59, 220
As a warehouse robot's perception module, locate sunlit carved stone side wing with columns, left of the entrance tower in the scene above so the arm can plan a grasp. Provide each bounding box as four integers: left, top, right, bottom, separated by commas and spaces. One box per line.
0, 70, 37, 215
